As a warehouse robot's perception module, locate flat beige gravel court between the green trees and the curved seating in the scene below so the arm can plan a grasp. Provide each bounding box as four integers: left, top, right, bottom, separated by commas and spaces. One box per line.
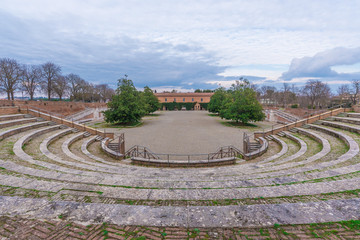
117, 111, 243, 154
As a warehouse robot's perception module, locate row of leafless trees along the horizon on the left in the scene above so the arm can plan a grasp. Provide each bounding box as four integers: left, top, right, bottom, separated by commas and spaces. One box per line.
0, 58, 115, 102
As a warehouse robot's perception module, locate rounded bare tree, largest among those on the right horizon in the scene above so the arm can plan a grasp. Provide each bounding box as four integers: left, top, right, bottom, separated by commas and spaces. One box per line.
303, 80, 331, 107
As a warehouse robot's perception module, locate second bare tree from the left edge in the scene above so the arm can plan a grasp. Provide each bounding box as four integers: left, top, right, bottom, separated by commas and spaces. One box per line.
21, 65, 42, 100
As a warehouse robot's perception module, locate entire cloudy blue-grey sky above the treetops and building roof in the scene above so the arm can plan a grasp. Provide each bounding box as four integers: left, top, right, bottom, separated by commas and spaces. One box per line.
0, 0, 360, 91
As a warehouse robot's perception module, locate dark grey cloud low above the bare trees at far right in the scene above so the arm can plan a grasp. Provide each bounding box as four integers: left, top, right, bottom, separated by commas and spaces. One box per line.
281, 47, 360, 80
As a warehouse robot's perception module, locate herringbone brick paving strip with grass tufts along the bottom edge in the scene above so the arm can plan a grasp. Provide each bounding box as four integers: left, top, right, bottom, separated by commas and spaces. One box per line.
0, 216, 360, 240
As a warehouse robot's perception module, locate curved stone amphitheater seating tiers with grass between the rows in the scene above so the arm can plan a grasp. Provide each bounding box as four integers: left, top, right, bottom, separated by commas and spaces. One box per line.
0, 110, 360, 227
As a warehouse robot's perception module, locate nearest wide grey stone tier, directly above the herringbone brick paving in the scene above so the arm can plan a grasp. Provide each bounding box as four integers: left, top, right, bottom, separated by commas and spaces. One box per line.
0, 196, 360, 227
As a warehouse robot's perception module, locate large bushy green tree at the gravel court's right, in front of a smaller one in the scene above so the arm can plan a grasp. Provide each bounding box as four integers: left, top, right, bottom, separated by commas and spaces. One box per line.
220, 79, 265, 124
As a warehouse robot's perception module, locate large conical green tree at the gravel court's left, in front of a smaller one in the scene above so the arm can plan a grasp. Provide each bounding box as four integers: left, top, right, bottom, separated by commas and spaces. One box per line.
104, 78, 145, 124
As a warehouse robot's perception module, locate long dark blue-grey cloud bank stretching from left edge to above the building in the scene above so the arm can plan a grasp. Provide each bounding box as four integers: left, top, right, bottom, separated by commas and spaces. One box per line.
0, 9, 229, 88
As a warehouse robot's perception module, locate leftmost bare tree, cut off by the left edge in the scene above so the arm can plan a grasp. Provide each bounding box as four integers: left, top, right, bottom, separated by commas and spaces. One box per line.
0, 58, 22, 100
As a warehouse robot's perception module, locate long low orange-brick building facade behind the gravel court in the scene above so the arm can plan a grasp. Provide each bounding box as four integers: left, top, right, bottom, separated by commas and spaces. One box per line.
155, 93, 214, 110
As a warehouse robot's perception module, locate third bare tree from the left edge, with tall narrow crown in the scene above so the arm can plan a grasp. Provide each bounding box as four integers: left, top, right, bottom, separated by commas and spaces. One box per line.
41, 62, 61, 100
